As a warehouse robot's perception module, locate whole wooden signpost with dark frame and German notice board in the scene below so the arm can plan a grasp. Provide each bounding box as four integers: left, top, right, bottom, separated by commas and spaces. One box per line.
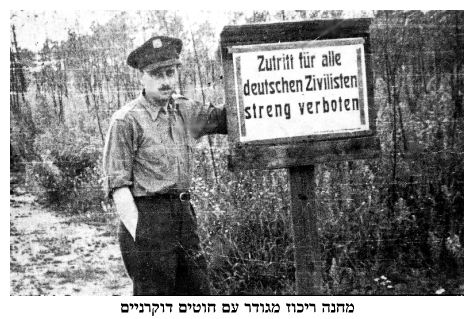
221, 19, 380, 294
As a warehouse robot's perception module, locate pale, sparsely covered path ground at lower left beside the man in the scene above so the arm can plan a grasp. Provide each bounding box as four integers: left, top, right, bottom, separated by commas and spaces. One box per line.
10, 195, 132, 296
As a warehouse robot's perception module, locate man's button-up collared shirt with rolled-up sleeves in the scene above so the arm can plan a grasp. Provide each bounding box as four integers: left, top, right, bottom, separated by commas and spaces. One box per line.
103, 94, 227, 197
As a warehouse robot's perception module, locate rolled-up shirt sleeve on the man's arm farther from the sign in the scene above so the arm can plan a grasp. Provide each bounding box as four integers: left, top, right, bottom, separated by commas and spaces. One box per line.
103, 119, 135, 198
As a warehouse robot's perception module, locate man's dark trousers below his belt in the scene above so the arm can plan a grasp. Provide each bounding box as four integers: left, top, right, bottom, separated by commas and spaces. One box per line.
119, 197, 210, 296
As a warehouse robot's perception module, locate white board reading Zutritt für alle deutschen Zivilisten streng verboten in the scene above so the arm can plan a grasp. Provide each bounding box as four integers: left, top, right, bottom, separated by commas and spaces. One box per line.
229, 38, 369, 142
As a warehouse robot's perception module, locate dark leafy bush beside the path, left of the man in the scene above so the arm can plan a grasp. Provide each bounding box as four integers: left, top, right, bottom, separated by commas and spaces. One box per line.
27, 127, 102, 214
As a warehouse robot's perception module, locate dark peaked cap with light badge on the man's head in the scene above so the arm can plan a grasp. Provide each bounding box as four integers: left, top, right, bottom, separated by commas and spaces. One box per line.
127, 36, 183, 71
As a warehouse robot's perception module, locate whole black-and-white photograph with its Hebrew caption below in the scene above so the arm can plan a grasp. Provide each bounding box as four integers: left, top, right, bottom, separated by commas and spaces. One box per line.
9, 8, 465, 308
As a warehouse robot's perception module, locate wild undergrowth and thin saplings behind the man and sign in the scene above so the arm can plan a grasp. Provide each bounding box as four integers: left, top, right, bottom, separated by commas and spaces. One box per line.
10, 11, 464, 294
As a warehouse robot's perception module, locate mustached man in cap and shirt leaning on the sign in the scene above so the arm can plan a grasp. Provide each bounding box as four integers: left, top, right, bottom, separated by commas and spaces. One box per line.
103, 36, 227, 295
